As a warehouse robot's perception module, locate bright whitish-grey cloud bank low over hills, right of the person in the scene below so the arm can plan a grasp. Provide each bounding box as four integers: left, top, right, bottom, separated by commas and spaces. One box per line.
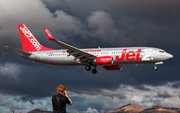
67, 84, 180, 111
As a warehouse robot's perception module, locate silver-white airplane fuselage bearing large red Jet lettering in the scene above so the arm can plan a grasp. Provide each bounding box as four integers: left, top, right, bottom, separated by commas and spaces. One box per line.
22, 47, 173, 66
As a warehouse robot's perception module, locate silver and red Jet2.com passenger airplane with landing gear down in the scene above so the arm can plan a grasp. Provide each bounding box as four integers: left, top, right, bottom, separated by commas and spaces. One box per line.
5, 24, 173, 74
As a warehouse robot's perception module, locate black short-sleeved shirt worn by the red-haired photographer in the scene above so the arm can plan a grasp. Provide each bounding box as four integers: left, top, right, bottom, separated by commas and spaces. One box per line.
52, 94, 70, 113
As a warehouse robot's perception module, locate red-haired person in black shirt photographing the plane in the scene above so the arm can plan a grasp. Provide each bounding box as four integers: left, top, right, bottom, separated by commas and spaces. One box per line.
52, 85, 72, 113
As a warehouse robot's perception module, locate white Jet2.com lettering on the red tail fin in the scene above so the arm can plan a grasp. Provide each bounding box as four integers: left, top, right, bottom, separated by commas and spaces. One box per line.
20, 26, 41, 51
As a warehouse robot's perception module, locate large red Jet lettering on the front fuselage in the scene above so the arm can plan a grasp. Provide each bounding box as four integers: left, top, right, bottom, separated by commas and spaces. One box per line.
116, 49, 142, 61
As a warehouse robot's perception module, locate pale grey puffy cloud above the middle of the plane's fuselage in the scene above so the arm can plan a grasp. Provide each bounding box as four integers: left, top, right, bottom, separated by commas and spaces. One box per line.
88, 11, 129, 44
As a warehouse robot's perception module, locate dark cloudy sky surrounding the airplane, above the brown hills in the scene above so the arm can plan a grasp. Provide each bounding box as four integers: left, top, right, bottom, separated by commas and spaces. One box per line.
0, 0, 180, 113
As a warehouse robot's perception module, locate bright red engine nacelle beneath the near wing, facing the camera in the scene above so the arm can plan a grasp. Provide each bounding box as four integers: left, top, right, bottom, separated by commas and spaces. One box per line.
94, 56, 113, 65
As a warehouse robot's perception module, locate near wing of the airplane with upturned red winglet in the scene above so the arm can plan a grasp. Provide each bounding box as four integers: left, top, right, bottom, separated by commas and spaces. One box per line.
44, 28, 96, 62
